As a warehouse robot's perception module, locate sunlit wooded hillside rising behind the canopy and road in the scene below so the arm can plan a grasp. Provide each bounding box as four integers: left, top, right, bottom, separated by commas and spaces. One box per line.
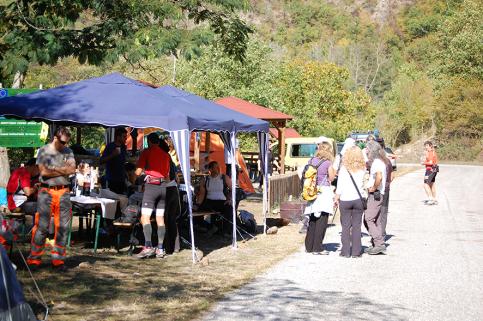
0, 0, 483, 160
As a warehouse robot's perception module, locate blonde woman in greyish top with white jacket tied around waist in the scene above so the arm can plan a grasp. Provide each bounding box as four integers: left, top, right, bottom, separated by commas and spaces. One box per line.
304, 142, 335, 255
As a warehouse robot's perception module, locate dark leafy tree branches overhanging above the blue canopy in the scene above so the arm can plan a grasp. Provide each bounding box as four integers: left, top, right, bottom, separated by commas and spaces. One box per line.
0, 0, 252, 86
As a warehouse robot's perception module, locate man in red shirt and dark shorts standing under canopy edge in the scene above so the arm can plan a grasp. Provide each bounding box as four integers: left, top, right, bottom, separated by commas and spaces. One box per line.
136, 133, 170, 259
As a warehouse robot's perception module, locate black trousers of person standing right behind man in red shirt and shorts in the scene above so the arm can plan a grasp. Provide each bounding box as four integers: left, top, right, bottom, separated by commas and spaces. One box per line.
163, 186, 180, 254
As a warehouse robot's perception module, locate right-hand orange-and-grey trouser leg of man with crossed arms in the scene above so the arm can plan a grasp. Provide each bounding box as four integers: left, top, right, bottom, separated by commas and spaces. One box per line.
52, 190, 72, 267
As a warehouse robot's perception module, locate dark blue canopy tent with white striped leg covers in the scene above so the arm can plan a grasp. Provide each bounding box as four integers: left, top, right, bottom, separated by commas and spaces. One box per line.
0, 73, 269, 261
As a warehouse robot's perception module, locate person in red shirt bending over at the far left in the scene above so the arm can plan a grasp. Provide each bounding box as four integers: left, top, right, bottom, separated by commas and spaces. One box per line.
7, 158, 39, 214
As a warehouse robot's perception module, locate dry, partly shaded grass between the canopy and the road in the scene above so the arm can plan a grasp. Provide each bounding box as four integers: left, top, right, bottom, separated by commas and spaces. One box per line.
14, 195, 304, 321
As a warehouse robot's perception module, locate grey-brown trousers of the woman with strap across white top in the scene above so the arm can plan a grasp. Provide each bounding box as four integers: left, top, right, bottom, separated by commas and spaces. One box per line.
339, 199, 364, 256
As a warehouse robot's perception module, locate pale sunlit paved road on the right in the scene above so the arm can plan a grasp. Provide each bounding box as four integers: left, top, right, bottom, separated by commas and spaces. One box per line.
203, 166, 483, 321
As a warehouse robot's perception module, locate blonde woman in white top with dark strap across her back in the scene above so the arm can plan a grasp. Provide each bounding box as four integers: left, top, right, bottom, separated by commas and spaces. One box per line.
335, 146, 366, 257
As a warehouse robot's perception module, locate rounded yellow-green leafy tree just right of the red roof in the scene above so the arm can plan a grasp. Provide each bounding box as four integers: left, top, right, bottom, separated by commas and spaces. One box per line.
276, 61, 374, 140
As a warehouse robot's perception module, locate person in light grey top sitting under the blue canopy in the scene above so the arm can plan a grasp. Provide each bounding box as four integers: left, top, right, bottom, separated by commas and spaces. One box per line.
196, 161, 233, 233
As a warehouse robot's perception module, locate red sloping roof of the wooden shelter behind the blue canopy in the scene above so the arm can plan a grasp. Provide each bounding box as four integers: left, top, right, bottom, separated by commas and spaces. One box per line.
216, 97, 293, 121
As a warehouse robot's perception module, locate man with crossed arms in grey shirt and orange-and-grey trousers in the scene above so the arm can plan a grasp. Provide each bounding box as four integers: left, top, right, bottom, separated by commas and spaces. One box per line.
27, 127, 75, 270
